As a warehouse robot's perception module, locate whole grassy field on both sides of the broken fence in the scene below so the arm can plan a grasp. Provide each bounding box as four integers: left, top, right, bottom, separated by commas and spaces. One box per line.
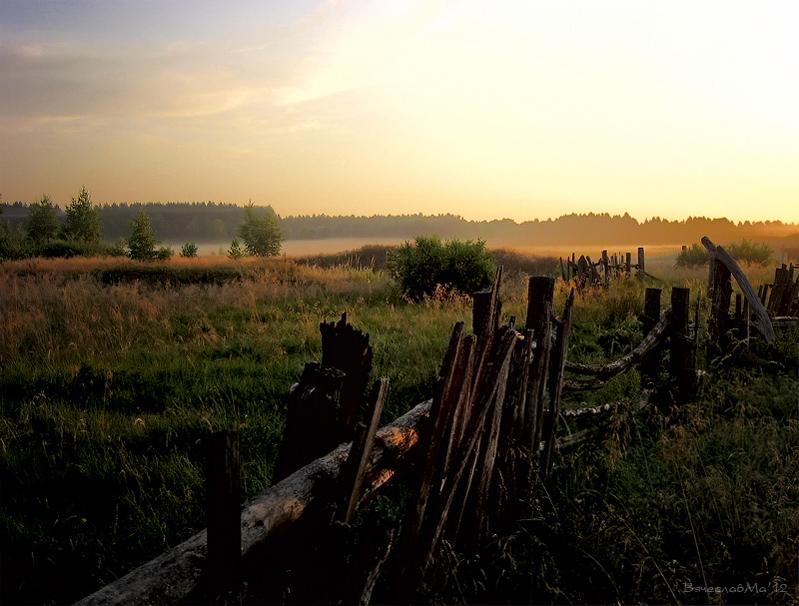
0, 251, 799, 603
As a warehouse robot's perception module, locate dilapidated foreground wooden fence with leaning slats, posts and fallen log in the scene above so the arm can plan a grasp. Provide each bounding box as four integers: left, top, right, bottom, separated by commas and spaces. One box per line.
80, 269, 708, 605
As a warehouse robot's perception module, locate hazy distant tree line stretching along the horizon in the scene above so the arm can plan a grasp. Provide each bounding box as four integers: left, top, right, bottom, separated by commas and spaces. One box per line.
0, 196, 799, 255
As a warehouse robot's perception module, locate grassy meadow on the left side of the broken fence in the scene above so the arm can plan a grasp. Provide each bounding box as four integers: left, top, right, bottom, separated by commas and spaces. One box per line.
0, 259, 476, 603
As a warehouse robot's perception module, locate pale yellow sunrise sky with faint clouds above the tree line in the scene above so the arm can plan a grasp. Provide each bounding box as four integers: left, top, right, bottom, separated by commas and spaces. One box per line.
0, 0, 799, 222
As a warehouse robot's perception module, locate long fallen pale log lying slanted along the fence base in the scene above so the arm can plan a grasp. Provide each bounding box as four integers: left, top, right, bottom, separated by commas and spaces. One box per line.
77, 400, 432, 606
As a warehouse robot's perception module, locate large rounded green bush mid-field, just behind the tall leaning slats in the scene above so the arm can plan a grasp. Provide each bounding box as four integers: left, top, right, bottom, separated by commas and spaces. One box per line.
388, 236, 496, 300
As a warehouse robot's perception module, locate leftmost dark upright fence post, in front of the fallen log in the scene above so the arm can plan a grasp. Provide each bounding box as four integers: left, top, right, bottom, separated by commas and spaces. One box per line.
204, 431, 241, 600
